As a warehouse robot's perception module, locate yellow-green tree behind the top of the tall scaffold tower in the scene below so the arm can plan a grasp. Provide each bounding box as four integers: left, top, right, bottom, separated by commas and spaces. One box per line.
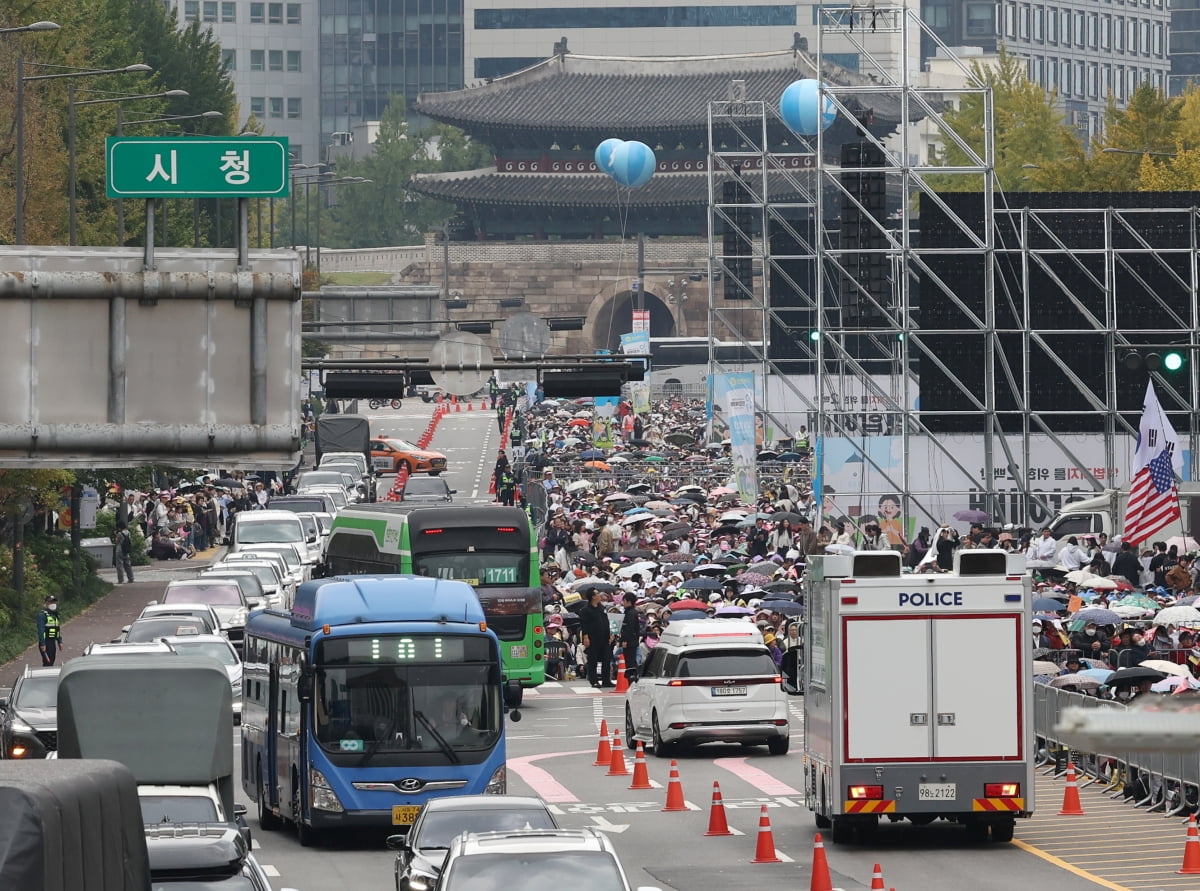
929, 52, 1084, 191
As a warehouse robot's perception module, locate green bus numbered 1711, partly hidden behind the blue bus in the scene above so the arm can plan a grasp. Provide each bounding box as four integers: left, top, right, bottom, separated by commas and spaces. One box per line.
325, 502, 546, 706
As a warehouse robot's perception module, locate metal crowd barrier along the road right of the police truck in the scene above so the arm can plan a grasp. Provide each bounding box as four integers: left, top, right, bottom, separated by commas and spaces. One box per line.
1033, 683, 1200, 817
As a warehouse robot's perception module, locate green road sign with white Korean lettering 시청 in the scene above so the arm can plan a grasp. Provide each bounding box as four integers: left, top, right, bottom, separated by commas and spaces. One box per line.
106, 136, 289, 198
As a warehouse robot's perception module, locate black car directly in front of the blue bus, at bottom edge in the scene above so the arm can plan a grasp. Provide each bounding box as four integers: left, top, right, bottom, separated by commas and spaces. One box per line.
388, 795, 561, 891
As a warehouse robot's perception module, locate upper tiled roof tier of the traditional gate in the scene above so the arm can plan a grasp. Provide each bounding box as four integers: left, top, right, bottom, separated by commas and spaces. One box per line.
416, 50, 900, 136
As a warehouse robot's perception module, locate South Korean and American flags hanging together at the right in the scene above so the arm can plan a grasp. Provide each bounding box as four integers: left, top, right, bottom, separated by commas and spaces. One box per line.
1124, 383, 1180, 544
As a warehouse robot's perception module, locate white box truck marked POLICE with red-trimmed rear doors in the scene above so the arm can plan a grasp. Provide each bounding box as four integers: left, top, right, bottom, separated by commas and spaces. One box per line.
800, 550, 1034, 842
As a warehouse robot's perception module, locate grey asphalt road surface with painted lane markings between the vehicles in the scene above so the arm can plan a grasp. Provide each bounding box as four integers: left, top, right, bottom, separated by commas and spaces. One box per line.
7, 402, 1200, 891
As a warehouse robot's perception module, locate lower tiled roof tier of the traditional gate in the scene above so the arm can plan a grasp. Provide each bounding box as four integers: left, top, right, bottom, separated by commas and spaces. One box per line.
408, 167, 811, 210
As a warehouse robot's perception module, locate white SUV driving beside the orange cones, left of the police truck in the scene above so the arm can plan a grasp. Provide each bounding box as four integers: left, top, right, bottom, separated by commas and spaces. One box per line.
625, 618, 791, 758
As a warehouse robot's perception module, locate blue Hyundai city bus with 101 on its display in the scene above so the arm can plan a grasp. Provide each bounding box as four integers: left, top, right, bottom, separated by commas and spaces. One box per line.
241, 575, 521, 845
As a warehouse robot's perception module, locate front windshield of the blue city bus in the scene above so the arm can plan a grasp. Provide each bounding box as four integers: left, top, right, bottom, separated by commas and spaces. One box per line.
314, 663, 502, 753
